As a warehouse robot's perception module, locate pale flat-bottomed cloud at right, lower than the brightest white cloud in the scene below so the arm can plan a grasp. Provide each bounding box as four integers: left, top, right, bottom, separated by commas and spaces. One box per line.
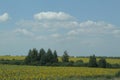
67, 20, 120, 36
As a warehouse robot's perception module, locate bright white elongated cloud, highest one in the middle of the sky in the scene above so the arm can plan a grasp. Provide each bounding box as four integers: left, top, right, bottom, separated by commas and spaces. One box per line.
34, 12, 74, 20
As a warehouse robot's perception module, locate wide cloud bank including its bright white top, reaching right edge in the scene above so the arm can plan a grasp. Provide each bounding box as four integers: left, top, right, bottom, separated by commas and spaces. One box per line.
17, 12, 120, 39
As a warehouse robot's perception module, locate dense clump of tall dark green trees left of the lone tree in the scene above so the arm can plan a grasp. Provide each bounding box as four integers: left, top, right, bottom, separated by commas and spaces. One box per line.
25, 48, 58, 65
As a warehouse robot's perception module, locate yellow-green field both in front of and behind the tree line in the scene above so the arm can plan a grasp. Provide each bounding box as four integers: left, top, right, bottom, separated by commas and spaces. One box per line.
0, 56, 120, 80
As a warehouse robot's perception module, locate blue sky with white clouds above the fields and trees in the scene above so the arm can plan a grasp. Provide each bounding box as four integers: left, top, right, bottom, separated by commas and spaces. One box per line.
0, 0, 120, 56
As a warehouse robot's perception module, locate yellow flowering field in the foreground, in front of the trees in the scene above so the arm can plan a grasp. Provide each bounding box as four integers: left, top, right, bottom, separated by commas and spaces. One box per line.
0, 65, 120, 80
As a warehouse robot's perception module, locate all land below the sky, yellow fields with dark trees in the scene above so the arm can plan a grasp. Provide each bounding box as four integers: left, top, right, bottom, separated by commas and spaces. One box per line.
0, 48, 120, 80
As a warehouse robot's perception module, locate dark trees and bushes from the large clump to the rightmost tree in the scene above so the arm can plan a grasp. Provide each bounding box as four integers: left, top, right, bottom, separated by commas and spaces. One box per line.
25, 48, 107, 68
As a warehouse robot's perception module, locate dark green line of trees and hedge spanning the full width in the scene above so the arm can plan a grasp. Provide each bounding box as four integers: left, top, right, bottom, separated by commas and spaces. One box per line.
0, 48, 120, 68
